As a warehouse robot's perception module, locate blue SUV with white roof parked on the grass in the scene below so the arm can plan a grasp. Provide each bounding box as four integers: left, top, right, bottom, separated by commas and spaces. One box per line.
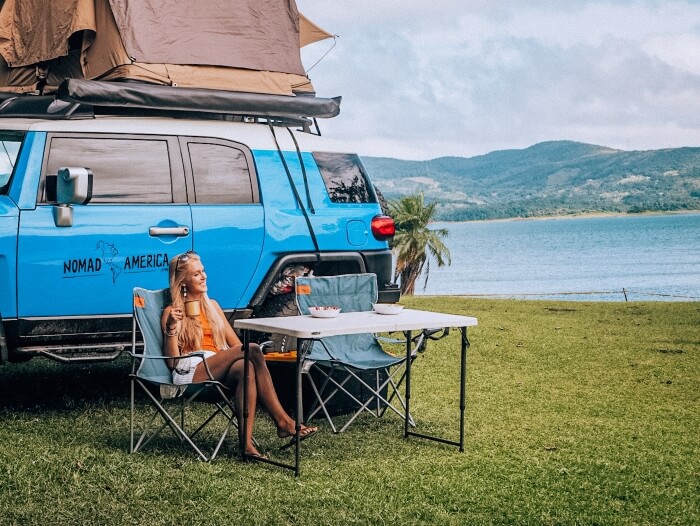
0, 95, 399, 362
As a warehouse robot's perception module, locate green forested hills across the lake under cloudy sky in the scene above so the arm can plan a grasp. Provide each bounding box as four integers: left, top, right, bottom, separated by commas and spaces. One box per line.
362, 141, 700, 221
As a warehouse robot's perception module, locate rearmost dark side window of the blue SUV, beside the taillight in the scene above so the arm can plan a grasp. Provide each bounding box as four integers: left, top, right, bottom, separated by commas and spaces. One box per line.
313, 152, 374, 203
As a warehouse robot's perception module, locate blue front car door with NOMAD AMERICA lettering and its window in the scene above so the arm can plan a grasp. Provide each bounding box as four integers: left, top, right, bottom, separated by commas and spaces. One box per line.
17, 133, 192, 322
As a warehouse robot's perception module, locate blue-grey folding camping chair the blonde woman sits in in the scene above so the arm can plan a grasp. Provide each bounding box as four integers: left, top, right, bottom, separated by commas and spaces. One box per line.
129, 287, 242, 462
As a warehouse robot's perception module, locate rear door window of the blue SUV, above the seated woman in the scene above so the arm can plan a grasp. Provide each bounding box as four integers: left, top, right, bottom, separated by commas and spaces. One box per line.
187, 142, 254, 204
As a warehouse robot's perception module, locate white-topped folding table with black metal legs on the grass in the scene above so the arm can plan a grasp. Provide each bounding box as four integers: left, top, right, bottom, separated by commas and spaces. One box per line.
234, 309, 477, 476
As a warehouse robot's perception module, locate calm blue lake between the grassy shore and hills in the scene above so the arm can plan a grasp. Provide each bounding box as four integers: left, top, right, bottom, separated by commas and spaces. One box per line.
416, 213, 700, 301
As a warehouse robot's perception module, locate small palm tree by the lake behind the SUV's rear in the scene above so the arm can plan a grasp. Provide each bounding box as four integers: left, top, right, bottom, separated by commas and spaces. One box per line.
389, 193, 452, 296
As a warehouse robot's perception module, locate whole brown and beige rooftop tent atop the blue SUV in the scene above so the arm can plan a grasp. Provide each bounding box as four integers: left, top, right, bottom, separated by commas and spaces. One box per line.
0, 0, 332, 95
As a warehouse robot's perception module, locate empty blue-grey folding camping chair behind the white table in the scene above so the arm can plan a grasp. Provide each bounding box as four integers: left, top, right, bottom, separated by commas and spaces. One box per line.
296, 274, 425, 433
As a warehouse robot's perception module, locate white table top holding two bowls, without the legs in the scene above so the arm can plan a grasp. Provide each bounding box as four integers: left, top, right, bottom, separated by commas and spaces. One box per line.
233, 309, 477, 339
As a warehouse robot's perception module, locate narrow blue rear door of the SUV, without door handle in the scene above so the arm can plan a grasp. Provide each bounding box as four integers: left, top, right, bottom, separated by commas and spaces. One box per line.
180, 137, 265, 309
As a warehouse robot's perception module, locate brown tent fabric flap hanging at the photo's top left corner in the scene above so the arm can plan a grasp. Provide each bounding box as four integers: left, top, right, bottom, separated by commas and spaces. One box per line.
0, 0, 95, 67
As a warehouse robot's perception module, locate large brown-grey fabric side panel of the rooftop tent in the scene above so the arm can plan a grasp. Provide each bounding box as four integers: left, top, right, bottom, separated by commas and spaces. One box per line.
110, 0, 305, 75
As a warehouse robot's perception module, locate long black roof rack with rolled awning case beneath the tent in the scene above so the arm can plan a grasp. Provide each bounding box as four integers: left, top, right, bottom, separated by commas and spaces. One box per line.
0, 79, 341, 128
